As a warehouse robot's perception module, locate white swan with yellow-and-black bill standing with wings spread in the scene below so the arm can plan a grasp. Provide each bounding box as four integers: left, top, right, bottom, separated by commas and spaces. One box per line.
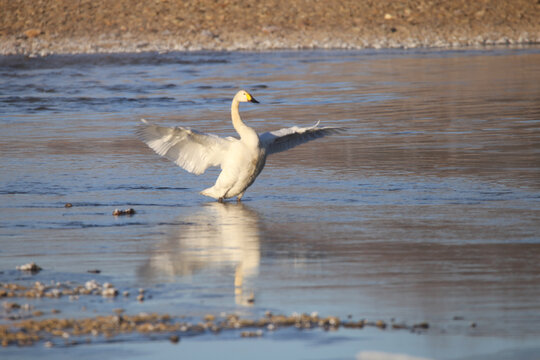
136, 90, 345, 202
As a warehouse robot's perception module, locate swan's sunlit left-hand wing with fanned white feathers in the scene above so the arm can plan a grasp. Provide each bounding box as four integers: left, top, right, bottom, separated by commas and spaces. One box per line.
136, 119, 230, 175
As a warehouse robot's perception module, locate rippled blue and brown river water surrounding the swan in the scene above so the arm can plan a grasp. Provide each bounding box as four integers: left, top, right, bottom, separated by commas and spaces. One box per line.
0, 48, 540, 359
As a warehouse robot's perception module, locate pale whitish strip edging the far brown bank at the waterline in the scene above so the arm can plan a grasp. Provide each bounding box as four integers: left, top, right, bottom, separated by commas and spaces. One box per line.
0, 33, 540, 57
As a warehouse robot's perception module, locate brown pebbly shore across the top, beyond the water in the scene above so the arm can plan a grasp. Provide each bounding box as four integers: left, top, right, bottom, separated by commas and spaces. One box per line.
0, 0, 540, 55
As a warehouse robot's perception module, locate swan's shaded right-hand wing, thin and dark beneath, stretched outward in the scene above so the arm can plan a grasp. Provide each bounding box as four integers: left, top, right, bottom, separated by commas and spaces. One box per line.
259, 123, 345, 155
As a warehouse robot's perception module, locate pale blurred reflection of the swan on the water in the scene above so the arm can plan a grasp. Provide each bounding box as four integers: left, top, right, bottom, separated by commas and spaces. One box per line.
140, 203, 260, 304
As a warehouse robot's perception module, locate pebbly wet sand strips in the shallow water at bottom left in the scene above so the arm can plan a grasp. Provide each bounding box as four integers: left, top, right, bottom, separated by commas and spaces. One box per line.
0, 278, 420, 347
